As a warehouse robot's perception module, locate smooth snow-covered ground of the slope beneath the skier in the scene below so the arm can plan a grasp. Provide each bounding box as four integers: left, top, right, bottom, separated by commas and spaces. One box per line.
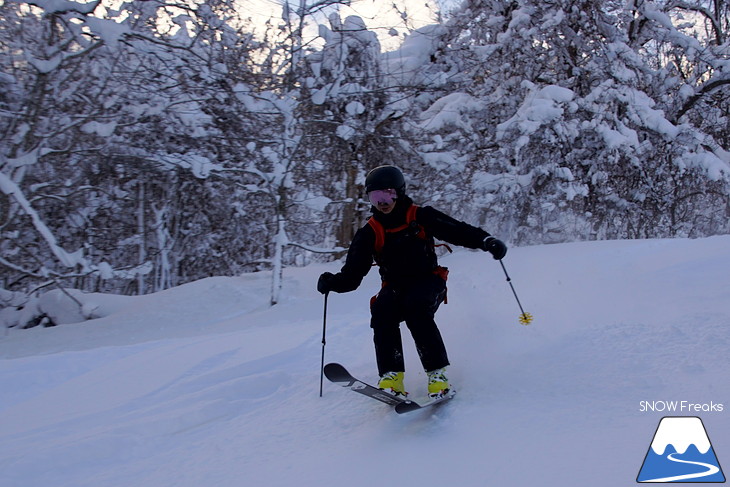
0, 236, 730, 487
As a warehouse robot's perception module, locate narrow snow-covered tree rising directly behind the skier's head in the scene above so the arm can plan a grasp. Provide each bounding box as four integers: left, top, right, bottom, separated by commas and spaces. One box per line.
302, 13, 402, 246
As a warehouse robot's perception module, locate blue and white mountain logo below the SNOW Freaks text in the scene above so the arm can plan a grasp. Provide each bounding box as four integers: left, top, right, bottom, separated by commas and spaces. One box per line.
636, 416, 725, 483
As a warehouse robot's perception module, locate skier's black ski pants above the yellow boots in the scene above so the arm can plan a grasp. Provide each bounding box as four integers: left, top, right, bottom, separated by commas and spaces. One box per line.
370, 274, 449, 376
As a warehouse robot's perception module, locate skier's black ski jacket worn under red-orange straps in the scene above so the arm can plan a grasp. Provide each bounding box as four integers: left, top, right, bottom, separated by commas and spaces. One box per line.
331, 196, 489, 293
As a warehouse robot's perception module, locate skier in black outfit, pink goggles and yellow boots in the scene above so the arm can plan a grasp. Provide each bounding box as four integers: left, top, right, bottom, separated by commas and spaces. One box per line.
317, 165, 507, 399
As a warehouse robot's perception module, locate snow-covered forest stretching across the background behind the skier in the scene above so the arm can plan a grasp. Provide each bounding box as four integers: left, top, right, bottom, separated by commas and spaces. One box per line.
0, 0, 730, 328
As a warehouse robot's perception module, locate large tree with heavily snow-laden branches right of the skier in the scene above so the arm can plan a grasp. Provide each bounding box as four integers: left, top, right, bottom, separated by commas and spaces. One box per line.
404, 0, 729, 242
